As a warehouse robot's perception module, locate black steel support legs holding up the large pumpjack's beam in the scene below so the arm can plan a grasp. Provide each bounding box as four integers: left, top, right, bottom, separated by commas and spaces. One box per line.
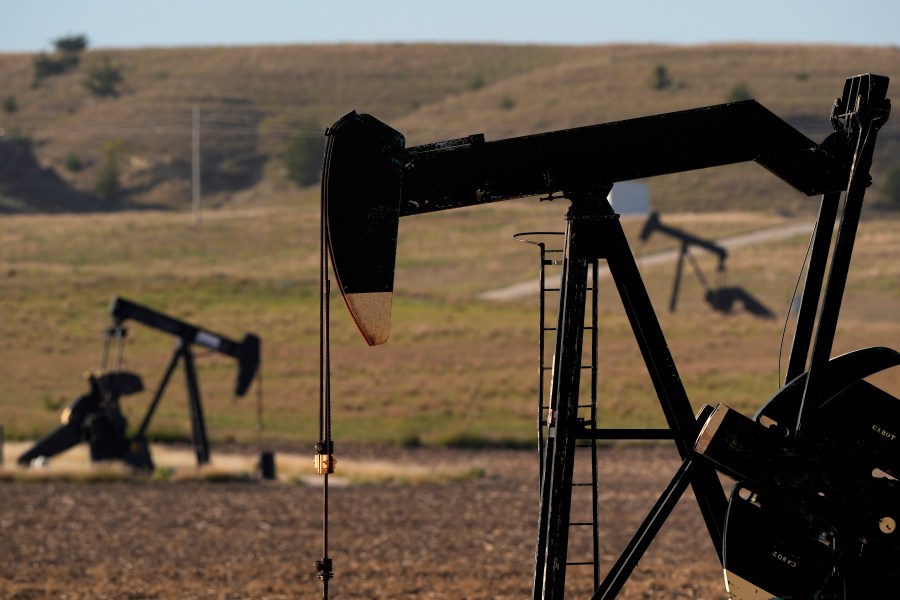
532, 187, 727, 600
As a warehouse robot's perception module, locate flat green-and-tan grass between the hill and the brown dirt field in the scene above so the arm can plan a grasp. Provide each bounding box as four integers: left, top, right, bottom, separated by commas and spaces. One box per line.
0, 200, 900, 445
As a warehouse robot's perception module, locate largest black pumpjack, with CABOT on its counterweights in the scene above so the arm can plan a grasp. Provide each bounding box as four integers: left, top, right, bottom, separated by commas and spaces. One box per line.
323, 74, 900, 600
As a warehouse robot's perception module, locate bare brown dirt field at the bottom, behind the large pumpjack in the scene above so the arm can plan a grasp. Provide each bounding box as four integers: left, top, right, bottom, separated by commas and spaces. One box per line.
0, 446, 725, 600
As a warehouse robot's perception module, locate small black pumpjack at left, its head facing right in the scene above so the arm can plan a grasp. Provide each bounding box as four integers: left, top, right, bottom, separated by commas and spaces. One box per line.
18, 297, 260, 471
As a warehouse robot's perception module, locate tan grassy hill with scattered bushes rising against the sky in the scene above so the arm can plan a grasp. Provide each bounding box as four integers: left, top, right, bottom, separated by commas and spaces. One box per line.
0, 44, 900, 211
